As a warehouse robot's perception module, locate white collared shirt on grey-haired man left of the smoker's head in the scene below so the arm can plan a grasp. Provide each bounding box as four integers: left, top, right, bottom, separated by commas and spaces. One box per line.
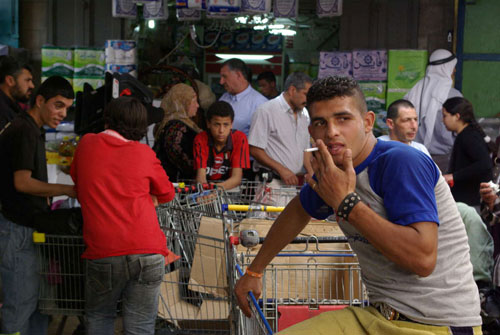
248, 93, 310, 174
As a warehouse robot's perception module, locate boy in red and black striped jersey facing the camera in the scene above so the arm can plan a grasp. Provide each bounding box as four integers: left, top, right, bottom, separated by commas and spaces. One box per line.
194, 101, 250, 190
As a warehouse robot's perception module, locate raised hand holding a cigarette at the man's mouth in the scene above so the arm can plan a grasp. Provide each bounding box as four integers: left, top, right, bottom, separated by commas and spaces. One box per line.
306, 140, 356, 210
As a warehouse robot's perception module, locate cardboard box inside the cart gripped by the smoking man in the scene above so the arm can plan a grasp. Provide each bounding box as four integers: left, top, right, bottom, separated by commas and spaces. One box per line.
237, 219, 363, 300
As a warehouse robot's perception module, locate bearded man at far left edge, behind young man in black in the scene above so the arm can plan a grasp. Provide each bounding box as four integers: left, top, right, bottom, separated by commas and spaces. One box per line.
0, 56, 35, 130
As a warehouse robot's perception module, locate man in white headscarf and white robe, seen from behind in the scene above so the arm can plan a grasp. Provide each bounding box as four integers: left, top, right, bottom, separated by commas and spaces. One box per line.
405, 49, 457, 155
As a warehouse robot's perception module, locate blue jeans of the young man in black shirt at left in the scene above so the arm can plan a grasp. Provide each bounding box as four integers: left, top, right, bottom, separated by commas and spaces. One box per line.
0, 214, 49, 335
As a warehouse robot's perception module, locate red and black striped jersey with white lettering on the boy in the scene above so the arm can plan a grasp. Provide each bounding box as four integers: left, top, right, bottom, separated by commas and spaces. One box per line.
193, 130, 250, 180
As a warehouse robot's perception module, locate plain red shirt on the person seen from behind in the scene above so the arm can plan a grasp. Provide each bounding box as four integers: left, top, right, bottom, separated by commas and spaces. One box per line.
71, 131, 175, 259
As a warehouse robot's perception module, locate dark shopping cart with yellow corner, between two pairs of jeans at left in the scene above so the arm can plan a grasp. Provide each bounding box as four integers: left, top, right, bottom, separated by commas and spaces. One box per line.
33, 232, 85, 334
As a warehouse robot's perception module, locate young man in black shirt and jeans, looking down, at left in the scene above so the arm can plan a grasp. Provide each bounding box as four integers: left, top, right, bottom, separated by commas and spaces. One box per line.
0, 76, 76, 334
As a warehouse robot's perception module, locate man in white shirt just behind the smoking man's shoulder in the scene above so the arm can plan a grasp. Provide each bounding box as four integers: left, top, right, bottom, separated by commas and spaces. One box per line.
378, 99, 430, 157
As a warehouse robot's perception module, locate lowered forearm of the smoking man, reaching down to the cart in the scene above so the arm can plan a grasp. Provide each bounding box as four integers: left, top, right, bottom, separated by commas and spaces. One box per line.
249, 196, 311, 273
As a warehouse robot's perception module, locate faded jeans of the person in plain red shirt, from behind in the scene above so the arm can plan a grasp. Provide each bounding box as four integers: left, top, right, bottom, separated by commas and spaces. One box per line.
85, 254, 165, 335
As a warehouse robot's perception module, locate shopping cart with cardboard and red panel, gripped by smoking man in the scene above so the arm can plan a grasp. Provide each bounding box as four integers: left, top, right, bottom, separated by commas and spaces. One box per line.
223, 205, 368, 331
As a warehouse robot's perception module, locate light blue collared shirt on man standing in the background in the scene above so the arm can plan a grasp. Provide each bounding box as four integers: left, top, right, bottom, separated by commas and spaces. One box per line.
219, 85, 267, 137
